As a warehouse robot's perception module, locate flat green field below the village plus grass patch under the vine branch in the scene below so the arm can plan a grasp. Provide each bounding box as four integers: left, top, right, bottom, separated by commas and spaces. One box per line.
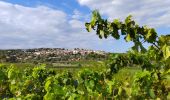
6, 61, 170, 89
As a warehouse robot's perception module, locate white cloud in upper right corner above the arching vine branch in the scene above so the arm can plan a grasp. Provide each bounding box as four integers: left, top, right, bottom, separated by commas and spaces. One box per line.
78, 0, 170, 27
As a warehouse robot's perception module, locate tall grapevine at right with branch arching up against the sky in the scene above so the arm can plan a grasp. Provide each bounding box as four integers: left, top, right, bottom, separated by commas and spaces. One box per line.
85, 10, 170, 99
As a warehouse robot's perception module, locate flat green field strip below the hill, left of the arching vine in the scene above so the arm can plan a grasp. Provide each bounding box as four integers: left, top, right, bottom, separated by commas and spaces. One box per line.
0, 61, 105, 73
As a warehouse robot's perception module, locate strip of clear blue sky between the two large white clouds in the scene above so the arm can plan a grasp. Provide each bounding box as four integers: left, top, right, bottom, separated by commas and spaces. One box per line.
2, 0, 90, 14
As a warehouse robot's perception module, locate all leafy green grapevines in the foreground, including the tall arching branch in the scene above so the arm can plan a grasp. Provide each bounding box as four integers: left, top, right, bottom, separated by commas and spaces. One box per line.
0, 11, 170, 100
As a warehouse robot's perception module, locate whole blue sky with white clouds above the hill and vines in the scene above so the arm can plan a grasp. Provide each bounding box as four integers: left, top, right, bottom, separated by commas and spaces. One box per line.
0, 0, 170, 52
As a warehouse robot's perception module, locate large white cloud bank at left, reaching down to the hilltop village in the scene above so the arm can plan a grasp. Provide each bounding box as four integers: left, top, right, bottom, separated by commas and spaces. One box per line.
0, 1, 119, 50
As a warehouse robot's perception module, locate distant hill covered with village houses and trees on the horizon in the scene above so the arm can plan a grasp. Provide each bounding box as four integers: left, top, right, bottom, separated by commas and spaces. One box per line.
0, 48, 108, 62
